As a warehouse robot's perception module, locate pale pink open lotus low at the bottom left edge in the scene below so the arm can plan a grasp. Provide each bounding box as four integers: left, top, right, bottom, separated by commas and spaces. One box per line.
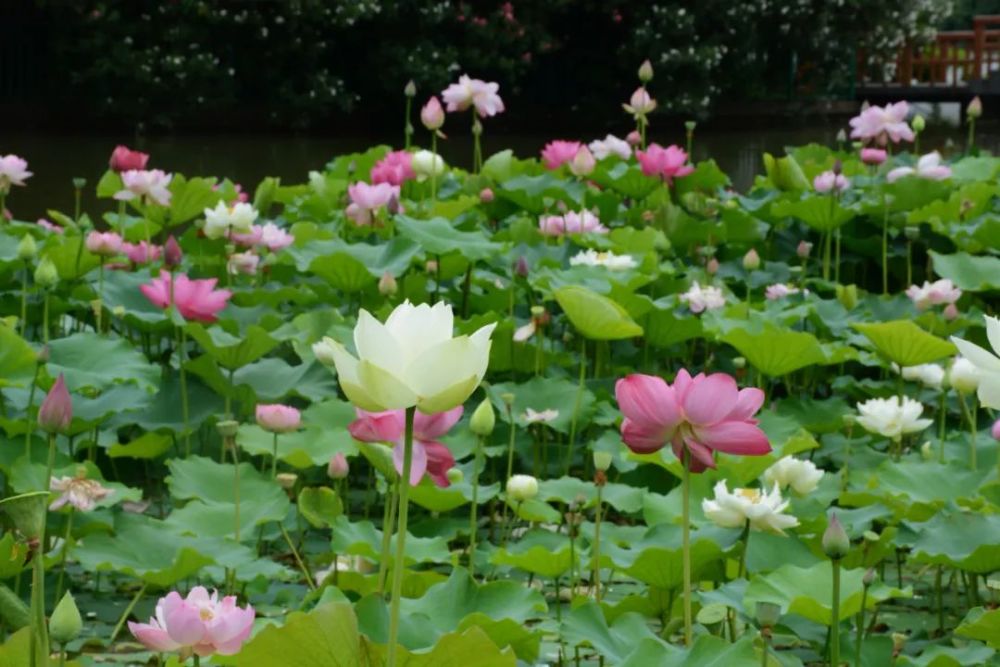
128, 586, 256, 657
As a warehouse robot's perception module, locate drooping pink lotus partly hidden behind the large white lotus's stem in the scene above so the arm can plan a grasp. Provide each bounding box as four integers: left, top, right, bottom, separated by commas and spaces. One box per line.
347, 405, 463, 488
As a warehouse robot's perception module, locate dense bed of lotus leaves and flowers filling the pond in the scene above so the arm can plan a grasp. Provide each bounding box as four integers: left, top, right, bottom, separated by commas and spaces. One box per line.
0, 77, 1000, 667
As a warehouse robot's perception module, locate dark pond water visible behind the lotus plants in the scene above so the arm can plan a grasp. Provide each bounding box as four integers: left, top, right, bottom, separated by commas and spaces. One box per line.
7, 105, 1000, 220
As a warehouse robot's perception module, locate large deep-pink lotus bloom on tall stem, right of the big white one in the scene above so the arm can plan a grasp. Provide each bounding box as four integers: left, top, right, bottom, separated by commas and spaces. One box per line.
615, 369, 771, 472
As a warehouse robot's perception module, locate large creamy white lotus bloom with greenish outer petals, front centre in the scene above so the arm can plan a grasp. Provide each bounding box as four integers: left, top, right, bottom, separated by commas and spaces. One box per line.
313, 301, 496, 414
